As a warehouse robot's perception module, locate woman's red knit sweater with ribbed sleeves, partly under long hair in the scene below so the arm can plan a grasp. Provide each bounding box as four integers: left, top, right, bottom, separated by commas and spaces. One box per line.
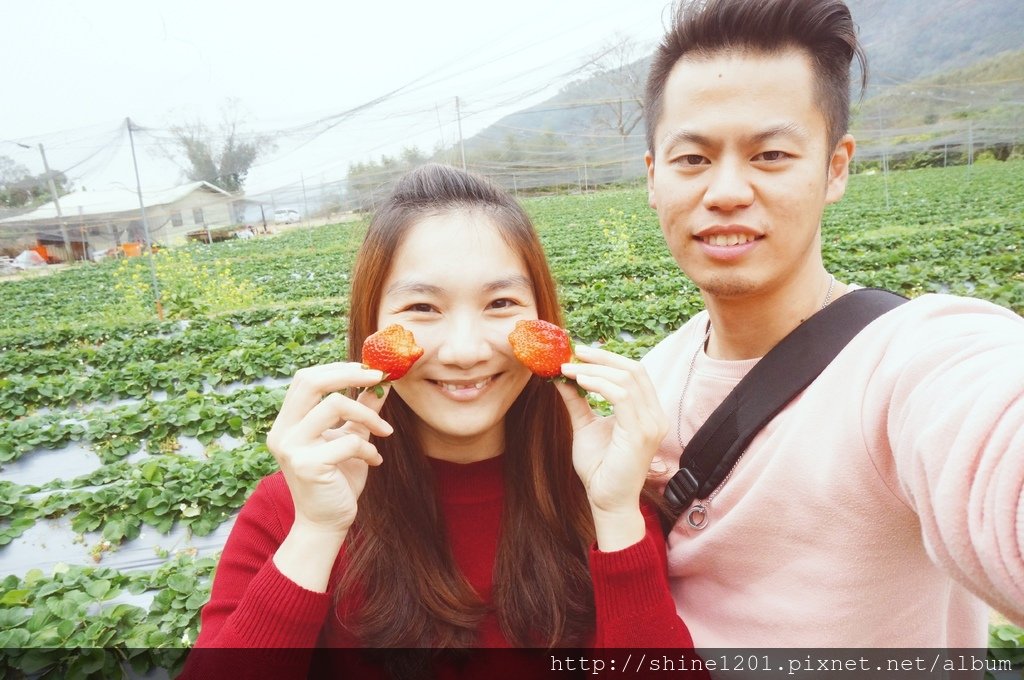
181, 457, 692, 678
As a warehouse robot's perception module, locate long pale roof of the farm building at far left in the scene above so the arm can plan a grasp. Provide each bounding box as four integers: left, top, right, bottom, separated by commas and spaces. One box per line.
0, 181, 232, 224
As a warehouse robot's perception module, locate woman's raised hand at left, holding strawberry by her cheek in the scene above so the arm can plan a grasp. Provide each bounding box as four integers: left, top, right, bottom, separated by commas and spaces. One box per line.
266, 363, 392, 540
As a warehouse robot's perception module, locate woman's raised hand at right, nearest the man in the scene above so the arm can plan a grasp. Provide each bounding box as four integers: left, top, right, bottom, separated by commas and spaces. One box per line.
557, 345, 668, 551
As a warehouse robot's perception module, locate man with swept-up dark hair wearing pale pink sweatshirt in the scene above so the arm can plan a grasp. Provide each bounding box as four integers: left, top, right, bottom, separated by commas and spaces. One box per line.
644, 0, 1024, 648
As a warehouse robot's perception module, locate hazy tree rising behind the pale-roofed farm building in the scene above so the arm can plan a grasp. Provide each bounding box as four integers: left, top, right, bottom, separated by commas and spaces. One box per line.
167, 100, 275, 194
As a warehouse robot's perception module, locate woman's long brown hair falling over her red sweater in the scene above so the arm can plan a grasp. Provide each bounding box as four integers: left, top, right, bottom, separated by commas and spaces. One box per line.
338, 165, 594, 648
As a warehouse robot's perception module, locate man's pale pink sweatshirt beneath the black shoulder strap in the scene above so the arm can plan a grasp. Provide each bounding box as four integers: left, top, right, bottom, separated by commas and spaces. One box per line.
643, 295, 1024, 648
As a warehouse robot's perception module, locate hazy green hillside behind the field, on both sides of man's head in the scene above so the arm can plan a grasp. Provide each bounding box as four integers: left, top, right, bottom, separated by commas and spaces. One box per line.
347, 0, 1024, 201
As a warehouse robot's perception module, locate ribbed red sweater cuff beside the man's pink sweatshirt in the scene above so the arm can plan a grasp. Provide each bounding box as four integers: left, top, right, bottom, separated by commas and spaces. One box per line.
590, 528, 669, 618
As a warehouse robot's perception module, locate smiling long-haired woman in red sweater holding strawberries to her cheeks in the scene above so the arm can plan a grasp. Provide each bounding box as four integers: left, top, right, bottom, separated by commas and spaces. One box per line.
186, 165, 691, 677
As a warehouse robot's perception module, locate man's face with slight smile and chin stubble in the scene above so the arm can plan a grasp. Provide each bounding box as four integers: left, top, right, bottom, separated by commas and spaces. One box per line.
647, 49, 854, 298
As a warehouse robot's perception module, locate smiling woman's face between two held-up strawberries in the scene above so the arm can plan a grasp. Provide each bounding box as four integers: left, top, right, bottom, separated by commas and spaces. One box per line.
377, 210, 538, 463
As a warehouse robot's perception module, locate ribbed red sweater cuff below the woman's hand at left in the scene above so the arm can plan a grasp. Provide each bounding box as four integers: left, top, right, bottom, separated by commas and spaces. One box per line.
231, 559, 331, 647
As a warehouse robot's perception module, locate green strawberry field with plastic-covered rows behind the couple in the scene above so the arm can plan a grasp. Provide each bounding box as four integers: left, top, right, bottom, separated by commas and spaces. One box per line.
0, 162, 1024, 678
